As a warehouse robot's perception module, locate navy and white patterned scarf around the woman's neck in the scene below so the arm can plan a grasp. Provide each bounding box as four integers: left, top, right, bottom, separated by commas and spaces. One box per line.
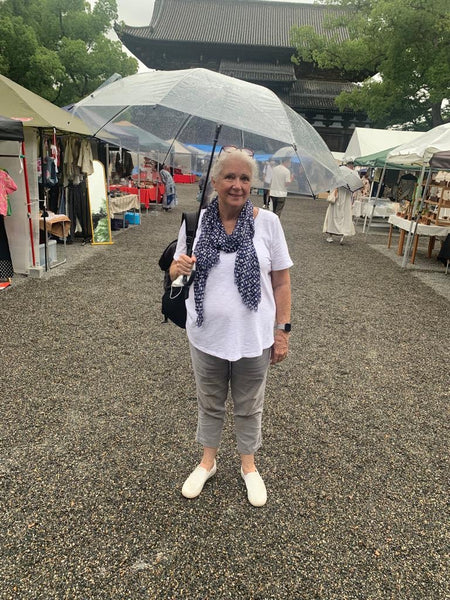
194, 198, 261, 327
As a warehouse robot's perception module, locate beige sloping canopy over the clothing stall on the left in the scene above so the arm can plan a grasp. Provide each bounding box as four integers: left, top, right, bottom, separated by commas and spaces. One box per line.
0, 75, 90, 135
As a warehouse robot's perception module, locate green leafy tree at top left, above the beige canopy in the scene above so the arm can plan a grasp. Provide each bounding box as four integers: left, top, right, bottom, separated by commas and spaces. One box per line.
0, 0, 138, 106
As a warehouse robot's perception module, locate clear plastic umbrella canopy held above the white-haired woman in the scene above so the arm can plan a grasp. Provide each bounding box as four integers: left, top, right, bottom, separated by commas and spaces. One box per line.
73, 69, 342, 194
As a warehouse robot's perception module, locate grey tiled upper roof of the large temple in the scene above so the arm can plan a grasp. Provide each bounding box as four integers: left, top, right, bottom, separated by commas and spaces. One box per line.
119, 0, 348, 48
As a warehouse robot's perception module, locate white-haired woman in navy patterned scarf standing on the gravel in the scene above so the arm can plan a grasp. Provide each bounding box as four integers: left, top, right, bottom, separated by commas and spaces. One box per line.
170, 147, 293, 506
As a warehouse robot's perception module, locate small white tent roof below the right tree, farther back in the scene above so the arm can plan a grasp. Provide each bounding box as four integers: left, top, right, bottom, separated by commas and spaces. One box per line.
343, 127, 423, 162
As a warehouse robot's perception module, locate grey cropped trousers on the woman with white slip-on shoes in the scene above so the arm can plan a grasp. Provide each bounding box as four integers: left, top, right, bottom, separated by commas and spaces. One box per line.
190, 344, 270, 454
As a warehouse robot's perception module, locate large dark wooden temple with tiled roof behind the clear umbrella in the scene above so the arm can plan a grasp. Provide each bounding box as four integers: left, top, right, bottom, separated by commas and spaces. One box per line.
116, 0, 369, 152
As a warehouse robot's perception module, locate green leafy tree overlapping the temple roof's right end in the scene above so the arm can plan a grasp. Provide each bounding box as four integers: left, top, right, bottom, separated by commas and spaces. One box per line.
291, 0, 450, 129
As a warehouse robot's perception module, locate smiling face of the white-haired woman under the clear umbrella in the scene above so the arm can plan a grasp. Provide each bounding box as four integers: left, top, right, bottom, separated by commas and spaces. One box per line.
213, 156, 252, 209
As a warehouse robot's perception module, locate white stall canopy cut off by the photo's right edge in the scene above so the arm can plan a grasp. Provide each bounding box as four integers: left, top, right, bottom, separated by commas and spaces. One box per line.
387, 123, 450, 167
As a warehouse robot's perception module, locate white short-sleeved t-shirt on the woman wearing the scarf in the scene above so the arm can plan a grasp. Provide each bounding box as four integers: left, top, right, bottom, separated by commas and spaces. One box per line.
174, 210, 293, 361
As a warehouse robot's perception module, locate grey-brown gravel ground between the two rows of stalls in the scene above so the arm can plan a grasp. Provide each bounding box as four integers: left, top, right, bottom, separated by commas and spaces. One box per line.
0, 186, 450, 600
